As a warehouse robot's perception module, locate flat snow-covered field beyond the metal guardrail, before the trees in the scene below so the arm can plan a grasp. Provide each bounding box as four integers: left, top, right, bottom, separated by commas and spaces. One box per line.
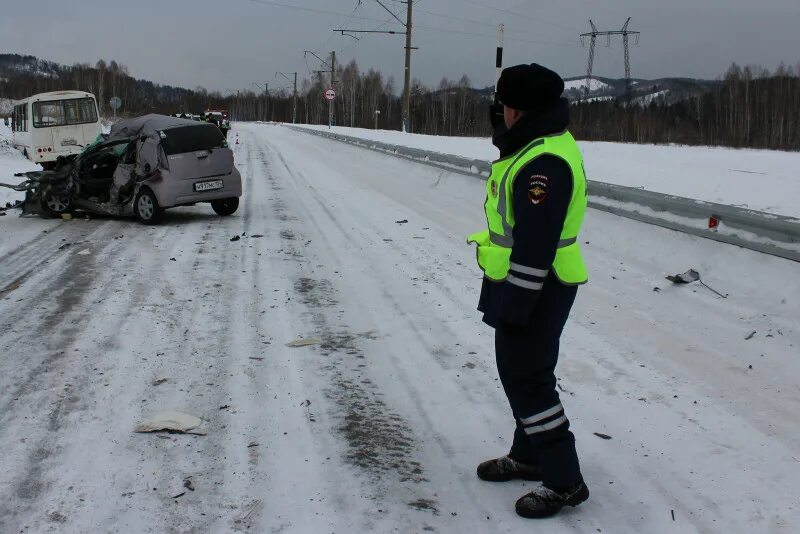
292, 125, 800, 217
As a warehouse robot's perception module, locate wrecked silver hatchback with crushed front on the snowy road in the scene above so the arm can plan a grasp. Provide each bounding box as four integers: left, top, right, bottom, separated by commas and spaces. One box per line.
0, 115, 242, 224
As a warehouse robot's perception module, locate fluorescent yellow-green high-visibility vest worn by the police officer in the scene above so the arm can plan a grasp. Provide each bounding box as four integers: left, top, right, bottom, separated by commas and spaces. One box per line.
467, 132, 589, 285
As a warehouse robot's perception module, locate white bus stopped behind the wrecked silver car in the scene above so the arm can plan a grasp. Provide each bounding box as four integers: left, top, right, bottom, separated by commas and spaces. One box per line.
11, 91, 100, 169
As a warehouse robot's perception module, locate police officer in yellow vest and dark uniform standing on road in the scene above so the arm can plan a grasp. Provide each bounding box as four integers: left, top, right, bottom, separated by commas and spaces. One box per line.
469, 63, 589, 518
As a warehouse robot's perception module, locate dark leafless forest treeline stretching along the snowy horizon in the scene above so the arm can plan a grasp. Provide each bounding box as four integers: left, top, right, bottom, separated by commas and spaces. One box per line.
0, 54, 800, 150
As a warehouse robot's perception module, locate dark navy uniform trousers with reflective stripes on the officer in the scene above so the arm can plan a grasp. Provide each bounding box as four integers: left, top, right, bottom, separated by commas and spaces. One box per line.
495, 273, 583, 488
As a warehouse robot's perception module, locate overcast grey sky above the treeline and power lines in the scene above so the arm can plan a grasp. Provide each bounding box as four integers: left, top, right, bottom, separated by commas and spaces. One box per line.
0, 0, 800, 93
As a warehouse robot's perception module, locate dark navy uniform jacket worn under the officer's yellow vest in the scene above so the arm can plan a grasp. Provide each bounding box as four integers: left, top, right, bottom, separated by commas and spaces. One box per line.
478, 99, 572, 328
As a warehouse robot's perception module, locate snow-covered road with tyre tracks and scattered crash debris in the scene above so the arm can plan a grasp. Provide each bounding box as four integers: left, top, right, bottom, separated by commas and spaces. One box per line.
0, 125, 800, 533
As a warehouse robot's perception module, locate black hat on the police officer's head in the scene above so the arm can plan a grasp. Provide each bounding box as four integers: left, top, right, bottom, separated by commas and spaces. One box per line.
497, 63, 564, 111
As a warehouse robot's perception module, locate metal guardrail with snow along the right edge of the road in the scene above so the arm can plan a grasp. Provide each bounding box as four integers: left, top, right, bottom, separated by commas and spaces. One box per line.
286, 126, 800, 262
